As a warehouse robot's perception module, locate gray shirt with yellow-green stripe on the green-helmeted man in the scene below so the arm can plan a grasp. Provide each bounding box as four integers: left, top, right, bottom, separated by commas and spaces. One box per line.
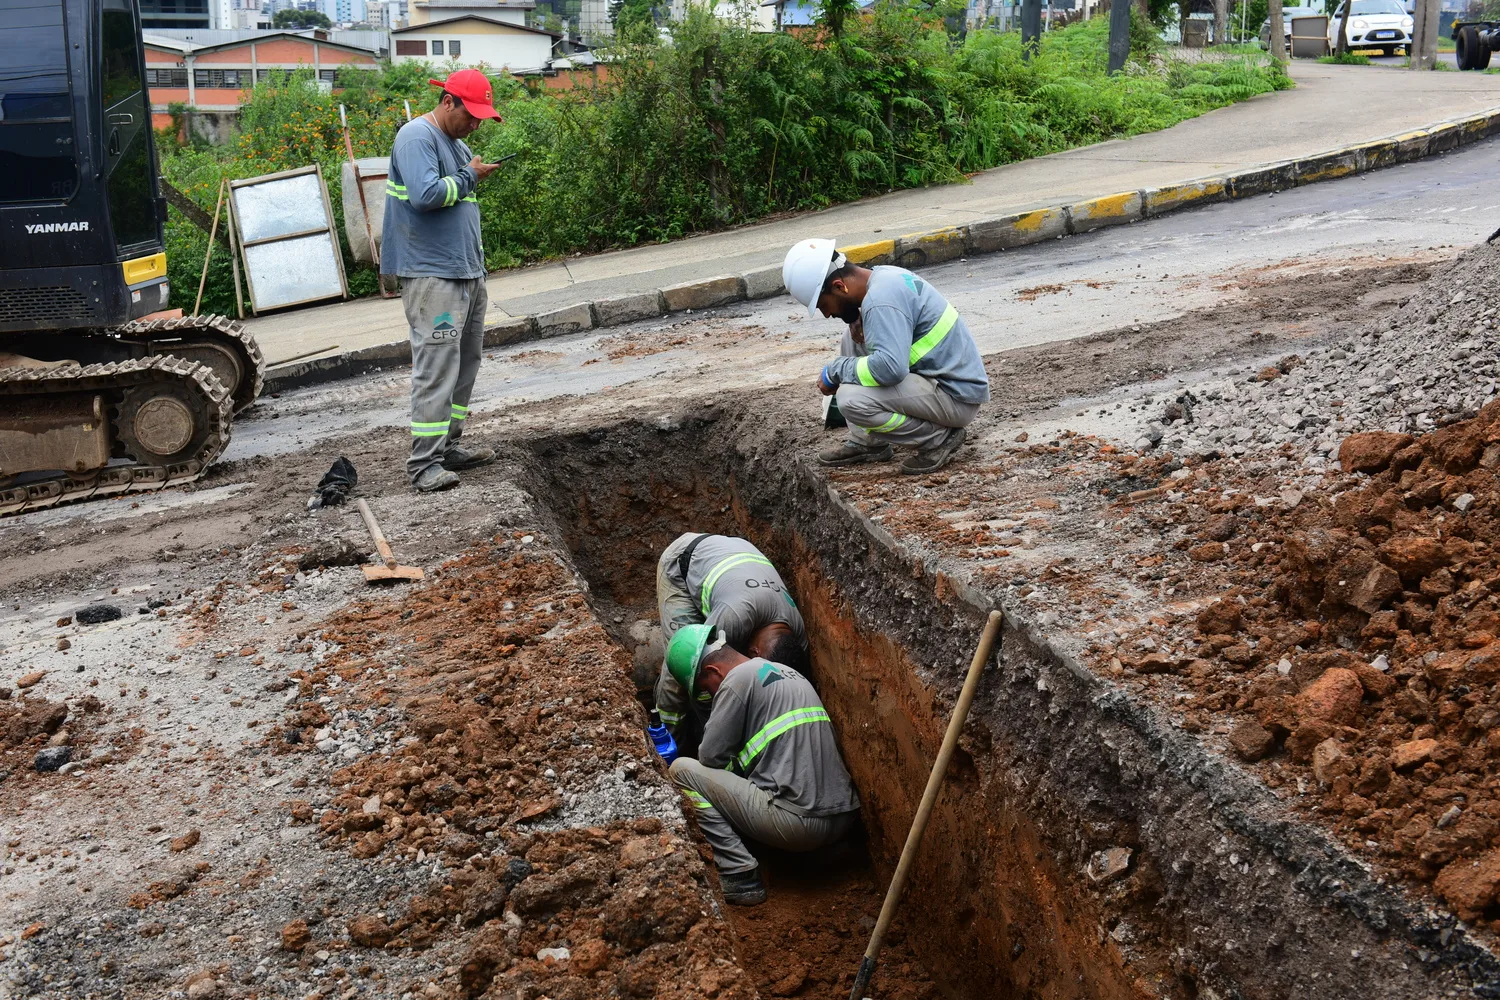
698, 658, 860, 816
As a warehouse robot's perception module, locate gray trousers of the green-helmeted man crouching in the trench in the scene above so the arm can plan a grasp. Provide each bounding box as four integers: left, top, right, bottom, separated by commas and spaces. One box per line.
672, 757, 860, 874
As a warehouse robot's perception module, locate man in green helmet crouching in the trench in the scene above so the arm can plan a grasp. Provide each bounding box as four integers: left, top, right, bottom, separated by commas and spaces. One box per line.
666, 625, 860, 906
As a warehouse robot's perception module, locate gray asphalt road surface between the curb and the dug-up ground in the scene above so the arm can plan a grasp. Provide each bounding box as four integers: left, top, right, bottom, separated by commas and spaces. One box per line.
214, 128, 1500, 460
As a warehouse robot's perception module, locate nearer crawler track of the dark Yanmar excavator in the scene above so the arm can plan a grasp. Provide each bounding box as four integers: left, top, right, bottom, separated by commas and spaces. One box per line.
0, 355, 231, 517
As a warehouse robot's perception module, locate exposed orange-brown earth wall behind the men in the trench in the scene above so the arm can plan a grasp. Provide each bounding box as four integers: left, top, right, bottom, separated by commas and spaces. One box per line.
536, 427, 1133, 997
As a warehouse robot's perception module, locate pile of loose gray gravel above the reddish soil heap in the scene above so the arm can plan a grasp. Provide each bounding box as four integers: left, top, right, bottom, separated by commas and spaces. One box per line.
1127, 243, 1500, 468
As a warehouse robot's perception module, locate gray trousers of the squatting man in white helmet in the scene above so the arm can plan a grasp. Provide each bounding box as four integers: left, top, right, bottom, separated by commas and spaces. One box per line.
837, 333, 980, 448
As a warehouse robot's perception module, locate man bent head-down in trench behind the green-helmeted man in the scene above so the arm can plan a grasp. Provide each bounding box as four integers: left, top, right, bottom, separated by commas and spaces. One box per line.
656, 531, 807, 748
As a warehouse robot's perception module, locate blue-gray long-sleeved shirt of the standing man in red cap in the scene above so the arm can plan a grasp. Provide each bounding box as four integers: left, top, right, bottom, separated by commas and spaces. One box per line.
380, 117, 485, 279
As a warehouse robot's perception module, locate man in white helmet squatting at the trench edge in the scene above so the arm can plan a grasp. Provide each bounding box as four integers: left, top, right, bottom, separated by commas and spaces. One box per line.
782, 240, 990, 475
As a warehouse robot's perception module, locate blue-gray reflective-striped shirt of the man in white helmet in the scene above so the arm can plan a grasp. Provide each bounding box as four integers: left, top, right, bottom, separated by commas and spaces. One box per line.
827, 265, 990, 403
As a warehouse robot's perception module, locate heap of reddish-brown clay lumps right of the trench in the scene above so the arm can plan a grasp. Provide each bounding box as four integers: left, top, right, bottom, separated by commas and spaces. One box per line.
1089, 402, 1500, 933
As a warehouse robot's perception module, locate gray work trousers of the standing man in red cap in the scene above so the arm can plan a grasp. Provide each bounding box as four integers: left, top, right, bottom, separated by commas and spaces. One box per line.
401, 277, 489, 483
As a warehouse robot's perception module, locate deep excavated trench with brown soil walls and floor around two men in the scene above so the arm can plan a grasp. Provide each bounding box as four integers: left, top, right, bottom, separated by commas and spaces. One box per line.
516, 421, 1134, 999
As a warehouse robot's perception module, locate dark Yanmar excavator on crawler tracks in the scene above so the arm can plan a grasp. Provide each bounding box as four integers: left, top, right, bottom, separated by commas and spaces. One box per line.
0, 0, 266, 516
